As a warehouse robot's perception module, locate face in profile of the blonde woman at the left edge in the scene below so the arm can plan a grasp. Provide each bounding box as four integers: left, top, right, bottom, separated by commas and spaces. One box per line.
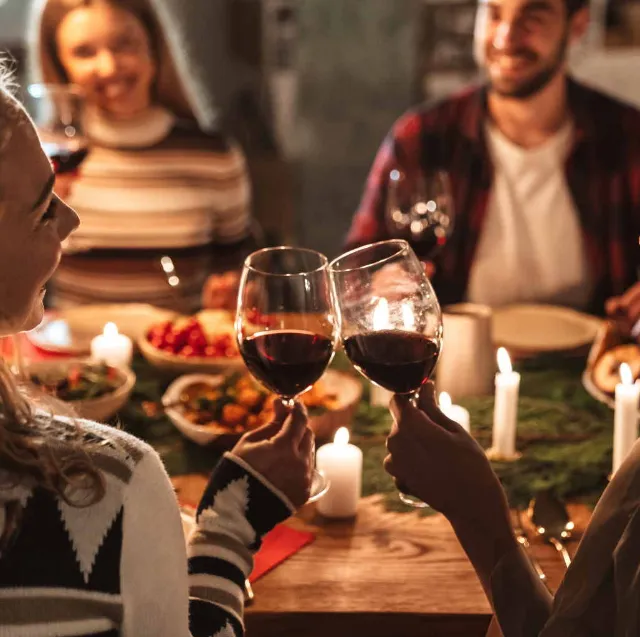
0, 92, 78, 335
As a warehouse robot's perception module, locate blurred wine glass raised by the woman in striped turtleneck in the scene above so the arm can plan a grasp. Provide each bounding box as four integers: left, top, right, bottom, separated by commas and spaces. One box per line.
26, 84, 89, 175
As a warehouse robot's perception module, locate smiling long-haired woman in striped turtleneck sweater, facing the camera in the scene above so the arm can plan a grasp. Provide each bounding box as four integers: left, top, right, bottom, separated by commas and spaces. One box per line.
29, 0, 255, 312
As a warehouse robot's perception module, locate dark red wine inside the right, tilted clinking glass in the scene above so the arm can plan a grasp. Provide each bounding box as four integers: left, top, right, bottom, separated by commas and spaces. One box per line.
344, 330, 440, 394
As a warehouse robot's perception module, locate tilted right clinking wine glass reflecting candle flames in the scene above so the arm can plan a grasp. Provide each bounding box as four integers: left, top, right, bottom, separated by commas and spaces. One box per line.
329, 239, 442, 507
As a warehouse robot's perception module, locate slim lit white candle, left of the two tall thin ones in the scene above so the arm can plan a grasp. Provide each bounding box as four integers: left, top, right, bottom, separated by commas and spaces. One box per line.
489, 347, 520, 459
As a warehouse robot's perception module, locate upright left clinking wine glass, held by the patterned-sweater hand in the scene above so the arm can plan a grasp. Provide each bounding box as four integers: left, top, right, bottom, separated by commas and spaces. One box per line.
236, 246, 339, 501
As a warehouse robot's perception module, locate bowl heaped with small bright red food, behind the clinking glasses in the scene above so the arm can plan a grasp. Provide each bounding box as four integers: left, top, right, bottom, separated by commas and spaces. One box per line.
137, 310, 244, 375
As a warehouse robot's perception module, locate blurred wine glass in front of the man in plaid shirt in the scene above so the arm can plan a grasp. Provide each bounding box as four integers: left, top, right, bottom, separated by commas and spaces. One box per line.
385, 168, 454, 261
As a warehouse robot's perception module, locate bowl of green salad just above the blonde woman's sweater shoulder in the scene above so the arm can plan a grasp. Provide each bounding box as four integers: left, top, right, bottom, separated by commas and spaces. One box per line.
28, 359, 136, 421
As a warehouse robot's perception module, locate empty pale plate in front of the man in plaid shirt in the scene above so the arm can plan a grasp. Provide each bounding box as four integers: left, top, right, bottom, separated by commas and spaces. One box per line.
493, 305, 602, 352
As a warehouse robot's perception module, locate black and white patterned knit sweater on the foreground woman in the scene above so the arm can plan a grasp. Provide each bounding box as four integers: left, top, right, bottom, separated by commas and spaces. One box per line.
0, 421, 293, 637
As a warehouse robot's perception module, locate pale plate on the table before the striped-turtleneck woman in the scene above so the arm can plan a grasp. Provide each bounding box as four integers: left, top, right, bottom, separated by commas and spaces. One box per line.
27, 303, 176, 355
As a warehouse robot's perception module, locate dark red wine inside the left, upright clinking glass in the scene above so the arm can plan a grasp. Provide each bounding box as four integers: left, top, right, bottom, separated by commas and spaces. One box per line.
240, 330, 333, 398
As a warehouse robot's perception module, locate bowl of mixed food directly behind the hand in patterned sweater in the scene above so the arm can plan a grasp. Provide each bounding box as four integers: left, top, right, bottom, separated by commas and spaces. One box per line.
162, 370, 362, 448
